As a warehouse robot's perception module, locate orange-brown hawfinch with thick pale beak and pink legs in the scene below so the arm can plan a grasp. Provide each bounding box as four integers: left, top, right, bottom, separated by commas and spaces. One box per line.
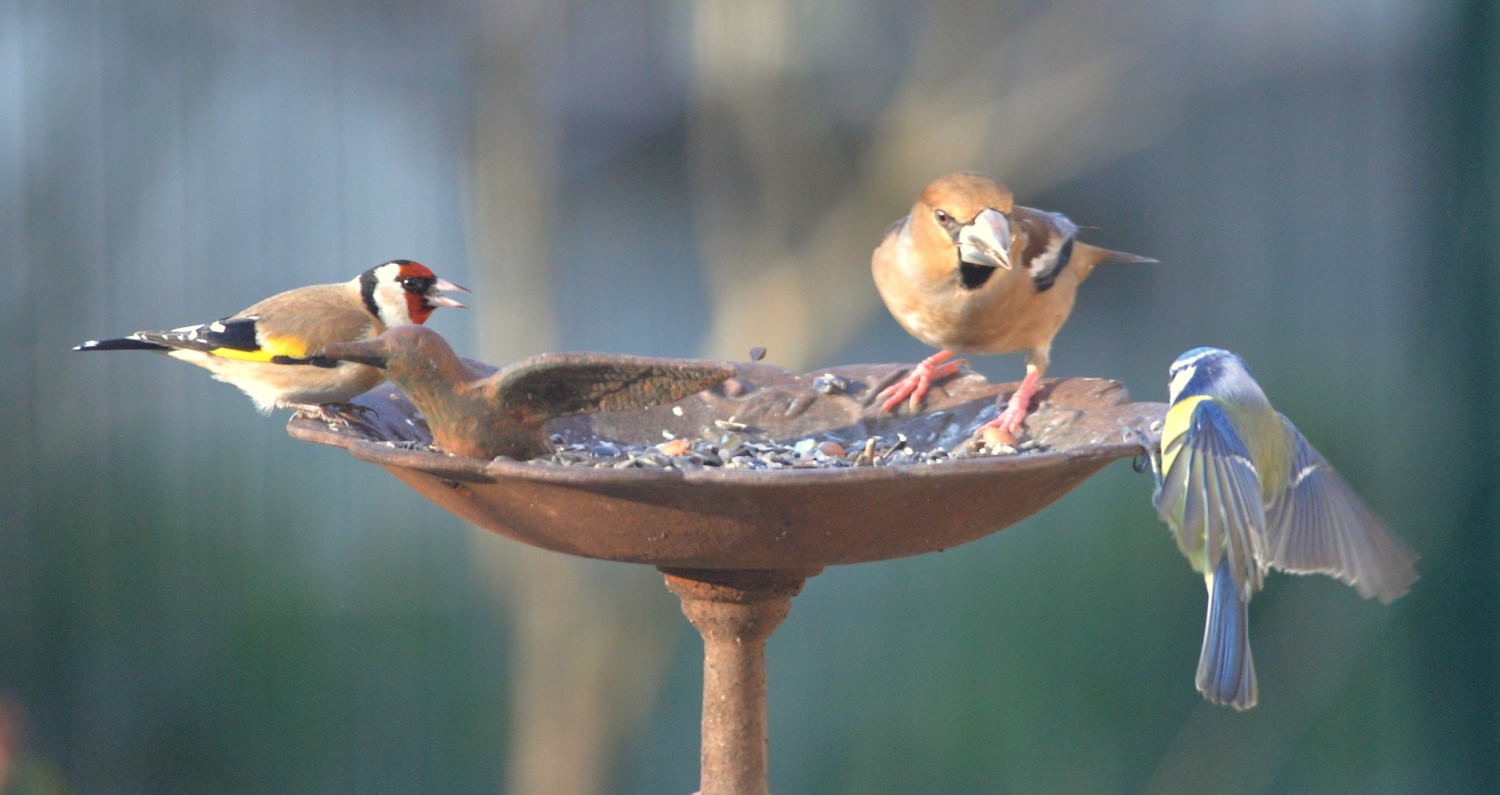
870, 173, 1155, 434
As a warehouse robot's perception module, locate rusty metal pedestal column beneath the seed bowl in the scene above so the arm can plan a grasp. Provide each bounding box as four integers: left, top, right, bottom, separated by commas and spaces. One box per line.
663, 569, 818, 795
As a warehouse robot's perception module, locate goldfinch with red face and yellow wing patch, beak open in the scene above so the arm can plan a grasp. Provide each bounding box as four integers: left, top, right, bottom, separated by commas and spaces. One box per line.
74, 260, 467, 414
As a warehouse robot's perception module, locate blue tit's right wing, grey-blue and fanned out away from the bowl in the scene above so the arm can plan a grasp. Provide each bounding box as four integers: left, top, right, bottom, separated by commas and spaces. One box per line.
1266, 417, 1418, 603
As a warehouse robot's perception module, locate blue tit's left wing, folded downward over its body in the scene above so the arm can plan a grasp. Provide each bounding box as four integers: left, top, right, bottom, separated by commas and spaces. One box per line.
1155, 396, 1266, 599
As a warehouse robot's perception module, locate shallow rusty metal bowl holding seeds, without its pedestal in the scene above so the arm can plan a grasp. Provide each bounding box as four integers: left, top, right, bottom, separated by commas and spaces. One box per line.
288, 363, 1166, 570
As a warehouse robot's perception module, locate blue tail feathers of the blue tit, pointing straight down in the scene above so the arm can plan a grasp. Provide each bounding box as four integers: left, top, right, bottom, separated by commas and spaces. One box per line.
1197, 555, 1257, 710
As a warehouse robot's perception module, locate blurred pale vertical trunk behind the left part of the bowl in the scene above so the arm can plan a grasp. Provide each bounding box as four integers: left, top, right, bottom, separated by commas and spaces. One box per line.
470, 2, 677, 795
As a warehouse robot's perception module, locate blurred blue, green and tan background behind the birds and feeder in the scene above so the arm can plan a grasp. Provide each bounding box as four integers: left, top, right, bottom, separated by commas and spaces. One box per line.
0, 0, 1500, 794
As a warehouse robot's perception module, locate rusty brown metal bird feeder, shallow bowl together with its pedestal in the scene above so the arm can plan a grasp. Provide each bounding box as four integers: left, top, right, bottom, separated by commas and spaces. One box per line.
287, 363, 1166, 795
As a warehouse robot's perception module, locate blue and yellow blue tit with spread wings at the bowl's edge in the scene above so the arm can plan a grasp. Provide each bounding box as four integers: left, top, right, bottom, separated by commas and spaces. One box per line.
1152, 348, 1418, 710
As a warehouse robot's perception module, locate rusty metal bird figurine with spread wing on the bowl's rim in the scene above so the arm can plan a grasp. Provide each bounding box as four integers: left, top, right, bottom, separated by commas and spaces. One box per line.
324, 326, 735, 461
